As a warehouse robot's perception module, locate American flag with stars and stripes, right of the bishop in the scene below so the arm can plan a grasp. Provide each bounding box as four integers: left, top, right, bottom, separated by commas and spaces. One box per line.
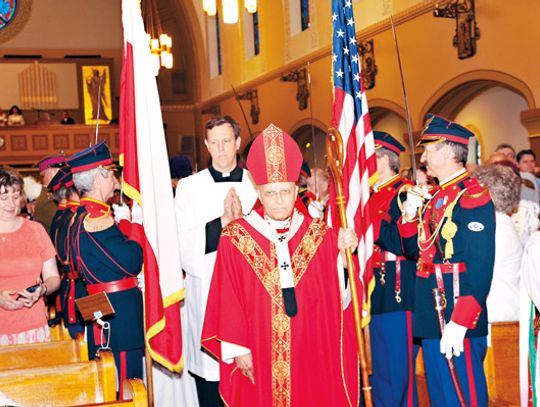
332, 0, 377, 325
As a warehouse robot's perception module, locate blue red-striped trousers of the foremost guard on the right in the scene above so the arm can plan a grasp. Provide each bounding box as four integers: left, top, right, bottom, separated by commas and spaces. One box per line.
422, 336, 488, 407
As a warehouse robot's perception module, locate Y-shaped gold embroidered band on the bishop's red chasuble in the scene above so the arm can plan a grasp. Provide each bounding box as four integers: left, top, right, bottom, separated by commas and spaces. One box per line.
223, 220, 327, 407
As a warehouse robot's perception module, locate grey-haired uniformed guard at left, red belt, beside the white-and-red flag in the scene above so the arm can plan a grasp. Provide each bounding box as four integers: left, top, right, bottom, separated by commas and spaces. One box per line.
68, 142, 144, 394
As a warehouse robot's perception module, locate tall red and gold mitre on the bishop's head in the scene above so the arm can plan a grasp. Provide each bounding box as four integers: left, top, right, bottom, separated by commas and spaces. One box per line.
247, 124, 302, 185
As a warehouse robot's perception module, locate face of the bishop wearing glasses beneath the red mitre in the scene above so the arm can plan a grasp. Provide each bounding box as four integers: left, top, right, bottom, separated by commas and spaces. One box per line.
257, 182, 298, 220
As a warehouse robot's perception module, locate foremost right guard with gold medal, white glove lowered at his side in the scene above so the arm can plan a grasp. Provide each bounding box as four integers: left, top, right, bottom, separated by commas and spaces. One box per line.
400, 115, 495, 406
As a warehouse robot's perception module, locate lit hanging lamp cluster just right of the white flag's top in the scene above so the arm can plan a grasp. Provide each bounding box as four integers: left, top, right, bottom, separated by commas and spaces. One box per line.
144, 0, 173, 75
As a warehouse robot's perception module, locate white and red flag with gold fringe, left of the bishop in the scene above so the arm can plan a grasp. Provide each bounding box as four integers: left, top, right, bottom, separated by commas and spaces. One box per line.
120, 0, 184, 372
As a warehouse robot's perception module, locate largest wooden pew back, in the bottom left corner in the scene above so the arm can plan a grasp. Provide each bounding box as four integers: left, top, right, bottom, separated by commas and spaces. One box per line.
0, 351, 116, 407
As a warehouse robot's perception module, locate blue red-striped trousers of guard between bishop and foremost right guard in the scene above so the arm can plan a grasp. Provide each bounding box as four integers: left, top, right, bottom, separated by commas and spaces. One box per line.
369, 311, 418, 407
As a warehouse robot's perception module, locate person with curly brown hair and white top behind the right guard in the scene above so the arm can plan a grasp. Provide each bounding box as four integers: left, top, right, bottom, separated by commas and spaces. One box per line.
474, 164, 523, 323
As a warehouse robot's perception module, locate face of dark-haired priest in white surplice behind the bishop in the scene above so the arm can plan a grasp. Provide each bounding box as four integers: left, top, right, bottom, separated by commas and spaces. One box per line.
204, 123, 240, 172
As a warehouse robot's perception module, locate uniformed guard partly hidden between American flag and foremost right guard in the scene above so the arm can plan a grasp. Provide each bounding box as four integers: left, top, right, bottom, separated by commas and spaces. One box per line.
369, 131, 417, 406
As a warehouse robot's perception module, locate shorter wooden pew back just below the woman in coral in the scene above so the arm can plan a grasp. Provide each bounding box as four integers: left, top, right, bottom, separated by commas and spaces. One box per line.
0, 335, 88, 371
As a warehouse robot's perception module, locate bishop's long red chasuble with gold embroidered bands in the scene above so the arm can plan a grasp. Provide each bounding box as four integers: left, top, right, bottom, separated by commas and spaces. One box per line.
202, 217, 359, 407
